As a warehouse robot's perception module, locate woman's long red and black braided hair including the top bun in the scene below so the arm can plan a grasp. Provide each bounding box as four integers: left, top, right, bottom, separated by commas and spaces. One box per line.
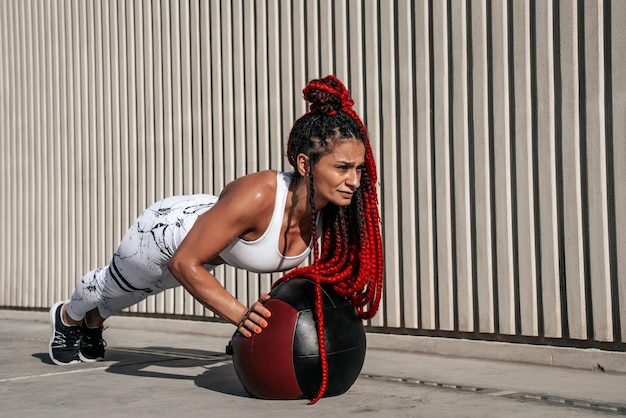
275, 75, 383, 405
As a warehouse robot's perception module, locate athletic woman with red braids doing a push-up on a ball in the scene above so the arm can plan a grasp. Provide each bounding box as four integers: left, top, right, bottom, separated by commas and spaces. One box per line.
49, 76, 383, 398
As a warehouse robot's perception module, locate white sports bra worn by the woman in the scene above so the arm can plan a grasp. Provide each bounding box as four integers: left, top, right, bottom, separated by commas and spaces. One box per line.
220, 172, 311, 273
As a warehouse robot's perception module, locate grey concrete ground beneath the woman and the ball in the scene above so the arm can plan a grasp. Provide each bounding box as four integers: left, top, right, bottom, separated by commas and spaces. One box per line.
0, 310, 626, 418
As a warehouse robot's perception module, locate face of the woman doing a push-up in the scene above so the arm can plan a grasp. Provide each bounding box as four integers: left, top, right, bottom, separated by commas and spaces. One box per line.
304, 138, 365, 210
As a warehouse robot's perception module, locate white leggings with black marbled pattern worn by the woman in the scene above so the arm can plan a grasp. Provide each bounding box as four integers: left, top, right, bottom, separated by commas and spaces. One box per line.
67, 194, 217, 321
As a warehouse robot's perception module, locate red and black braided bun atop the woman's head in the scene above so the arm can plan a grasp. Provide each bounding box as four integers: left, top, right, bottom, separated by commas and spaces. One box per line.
302, 75, 354, 115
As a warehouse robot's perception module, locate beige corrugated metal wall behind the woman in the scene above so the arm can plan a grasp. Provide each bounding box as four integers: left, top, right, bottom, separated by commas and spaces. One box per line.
0, 0, 626, 350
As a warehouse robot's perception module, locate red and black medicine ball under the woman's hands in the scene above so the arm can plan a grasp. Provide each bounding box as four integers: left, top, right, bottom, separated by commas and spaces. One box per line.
229, 279, 365, 399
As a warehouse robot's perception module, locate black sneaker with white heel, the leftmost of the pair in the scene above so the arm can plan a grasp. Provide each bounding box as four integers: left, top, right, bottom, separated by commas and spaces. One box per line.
49, 302, 80, 366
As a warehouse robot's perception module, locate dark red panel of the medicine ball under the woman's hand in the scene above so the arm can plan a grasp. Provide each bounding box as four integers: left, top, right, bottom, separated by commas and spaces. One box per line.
232, 299, 303, 399
